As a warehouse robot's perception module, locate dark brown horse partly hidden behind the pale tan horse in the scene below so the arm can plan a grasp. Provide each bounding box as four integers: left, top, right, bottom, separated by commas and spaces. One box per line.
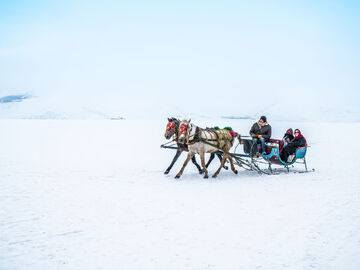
164, 117, 228, 174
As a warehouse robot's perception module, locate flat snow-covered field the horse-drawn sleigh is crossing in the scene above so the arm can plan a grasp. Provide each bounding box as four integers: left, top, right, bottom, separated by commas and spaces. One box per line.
0, 119, 360, 270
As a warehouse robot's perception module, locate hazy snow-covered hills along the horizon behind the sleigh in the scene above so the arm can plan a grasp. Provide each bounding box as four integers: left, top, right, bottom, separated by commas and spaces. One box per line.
0, 93, 360, 122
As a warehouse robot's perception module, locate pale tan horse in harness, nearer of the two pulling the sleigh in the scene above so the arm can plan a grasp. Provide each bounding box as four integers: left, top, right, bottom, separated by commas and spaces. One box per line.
175, 120, 241, 178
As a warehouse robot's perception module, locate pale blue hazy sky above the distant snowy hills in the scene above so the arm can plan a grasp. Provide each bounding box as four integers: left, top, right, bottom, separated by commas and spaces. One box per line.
0, 0, 360, 118
